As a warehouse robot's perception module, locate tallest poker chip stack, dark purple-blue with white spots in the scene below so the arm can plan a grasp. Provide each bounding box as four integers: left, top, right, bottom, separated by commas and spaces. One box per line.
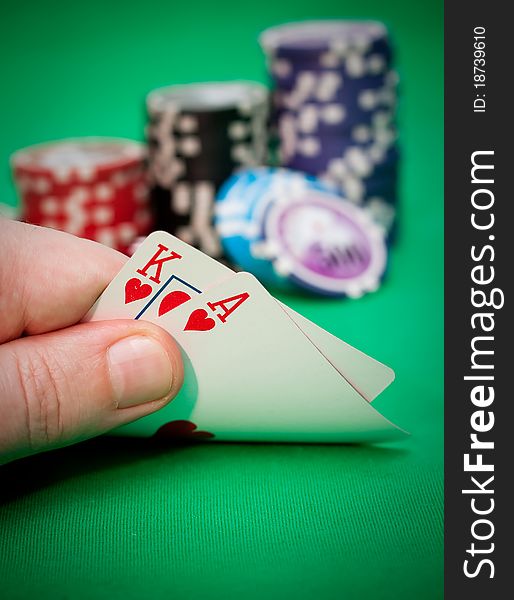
260, 21, 398, 237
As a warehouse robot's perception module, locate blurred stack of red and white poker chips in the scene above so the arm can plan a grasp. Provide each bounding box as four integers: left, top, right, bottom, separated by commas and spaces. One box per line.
11, 138, 152, 253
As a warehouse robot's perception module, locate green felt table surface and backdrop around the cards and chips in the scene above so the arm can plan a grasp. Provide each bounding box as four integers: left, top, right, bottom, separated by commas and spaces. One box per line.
0, 0, 443, 600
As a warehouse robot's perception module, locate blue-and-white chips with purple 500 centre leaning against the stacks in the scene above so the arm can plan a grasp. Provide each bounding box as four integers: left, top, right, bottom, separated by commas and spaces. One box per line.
215, 167, 387, 298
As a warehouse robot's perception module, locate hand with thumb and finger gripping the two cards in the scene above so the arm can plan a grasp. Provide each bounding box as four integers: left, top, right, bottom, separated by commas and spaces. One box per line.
0, 218, 183, 463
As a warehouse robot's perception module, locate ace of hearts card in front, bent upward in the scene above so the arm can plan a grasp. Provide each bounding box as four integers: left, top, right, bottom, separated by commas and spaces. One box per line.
112, 273, 403, 442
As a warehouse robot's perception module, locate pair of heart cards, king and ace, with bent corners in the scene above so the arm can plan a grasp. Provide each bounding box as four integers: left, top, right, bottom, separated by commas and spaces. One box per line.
85, 232, 405, 443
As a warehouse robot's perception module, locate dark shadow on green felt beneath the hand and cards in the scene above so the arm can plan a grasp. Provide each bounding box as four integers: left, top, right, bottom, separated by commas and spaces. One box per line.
0, 435, 410, 504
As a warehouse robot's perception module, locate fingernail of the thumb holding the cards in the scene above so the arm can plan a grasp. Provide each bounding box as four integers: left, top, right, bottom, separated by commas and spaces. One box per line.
107, 336, 173, 408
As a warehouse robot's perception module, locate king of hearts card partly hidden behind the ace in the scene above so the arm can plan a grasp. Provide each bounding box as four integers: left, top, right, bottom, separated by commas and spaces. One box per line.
84, 231, 394, 401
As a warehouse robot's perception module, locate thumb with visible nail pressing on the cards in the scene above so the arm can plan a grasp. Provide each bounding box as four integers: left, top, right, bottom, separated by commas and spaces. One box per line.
0, 320, 183, 463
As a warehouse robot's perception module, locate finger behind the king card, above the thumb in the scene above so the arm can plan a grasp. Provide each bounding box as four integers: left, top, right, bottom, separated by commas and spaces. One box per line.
0, 219, 127, 343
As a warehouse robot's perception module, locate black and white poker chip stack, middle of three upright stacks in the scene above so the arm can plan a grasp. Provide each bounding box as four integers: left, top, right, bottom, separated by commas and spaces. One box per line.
147, 82, 269, 258
